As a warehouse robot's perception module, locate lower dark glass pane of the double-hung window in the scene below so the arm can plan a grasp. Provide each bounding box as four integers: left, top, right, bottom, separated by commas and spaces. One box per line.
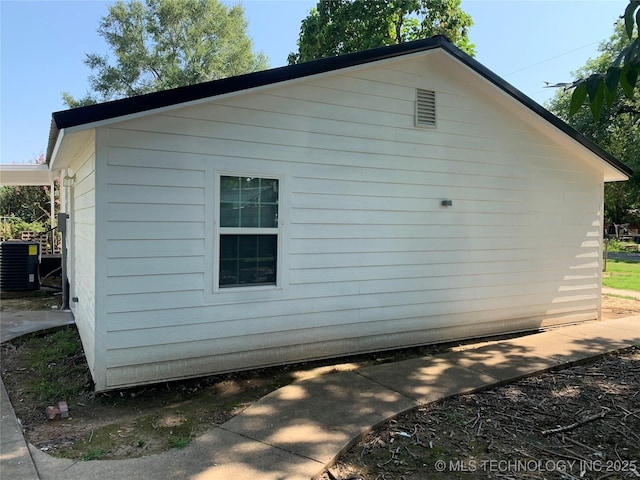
220, 235, 278, 287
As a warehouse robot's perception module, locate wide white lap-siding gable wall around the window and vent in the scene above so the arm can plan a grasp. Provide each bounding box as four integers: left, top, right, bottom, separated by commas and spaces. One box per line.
101, 55, 602, 388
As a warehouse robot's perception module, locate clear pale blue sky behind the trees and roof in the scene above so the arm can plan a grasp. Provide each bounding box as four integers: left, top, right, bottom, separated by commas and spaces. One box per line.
0, 0, 628, 163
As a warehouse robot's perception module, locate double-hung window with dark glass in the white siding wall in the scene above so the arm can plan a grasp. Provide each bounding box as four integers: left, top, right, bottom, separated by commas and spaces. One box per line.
218, 176, 278, 288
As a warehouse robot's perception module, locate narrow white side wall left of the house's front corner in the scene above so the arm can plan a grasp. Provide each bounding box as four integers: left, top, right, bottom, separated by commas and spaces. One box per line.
63, 130, 96, 376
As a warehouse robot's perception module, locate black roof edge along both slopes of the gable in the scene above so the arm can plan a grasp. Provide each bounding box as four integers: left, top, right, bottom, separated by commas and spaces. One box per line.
47, 35, 633, 177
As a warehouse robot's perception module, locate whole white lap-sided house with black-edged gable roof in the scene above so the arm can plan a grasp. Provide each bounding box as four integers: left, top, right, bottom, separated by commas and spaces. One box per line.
47, 37, 631, 391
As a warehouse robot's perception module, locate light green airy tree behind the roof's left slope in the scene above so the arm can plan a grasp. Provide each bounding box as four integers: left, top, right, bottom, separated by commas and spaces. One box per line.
63, 0, 268, 107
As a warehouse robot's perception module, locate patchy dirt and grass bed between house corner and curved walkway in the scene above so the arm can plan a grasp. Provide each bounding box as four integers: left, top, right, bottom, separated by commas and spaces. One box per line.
0, 326, 304, 461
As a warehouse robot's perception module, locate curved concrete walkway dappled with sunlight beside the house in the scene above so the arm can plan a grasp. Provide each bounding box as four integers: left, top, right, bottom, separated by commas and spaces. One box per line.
1, 316, 640, 480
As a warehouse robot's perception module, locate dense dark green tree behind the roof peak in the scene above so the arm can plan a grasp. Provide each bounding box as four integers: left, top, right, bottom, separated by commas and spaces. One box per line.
288, 0, 474, 64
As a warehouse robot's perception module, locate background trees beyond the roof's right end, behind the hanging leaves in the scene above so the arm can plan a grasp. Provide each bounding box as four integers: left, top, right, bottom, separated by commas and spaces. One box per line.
548, 23, 640, 224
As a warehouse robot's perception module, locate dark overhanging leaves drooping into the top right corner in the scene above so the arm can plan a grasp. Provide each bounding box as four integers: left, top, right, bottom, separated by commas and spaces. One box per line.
569, 0, 640, 119
